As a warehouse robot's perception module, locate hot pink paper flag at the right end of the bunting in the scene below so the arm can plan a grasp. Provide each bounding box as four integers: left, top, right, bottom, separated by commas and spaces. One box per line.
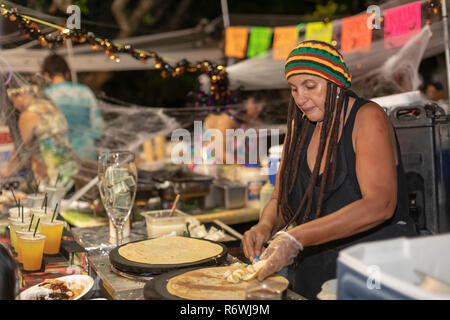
384, 1, 421, 49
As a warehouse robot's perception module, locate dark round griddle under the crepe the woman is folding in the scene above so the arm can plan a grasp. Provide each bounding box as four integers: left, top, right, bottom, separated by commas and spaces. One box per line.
144, 268, 287, 300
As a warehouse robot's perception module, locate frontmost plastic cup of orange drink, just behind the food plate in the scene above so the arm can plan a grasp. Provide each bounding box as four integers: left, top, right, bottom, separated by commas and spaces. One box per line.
20, 234, 47, 271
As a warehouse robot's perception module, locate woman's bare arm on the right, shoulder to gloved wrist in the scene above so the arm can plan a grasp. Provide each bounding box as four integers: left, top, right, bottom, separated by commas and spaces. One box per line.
289, 103, 397, 246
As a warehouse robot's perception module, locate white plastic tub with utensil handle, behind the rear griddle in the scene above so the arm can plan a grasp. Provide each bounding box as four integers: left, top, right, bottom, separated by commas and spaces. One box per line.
141, 210, 189, 238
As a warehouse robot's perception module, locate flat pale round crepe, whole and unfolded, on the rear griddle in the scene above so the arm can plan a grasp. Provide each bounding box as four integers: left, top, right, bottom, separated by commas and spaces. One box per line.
119, 236, 223, 265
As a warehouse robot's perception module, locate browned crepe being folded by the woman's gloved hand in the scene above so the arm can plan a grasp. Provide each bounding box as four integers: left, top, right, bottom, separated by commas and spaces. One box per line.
166, 266, 289, 300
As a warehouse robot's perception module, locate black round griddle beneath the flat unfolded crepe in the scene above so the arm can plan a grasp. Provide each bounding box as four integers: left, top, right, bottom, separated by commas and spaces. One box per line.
109, 239, 227, 275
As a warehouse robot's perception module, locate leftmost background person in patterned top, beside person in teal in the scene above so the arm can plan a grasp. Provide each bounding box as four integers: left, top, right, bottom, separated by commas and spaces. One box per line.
0, 80, 78, 189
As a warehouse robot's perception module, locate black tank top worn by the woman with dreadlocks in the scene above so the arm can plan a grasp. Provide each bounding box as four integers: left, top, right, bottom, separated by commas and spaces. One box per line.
288, 98, 417, 299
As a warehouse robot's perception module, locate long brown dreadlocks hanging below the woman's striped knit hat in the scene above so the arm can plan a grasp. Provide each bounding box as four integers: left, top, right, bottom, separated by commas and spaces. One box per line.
277, 81, 357, 228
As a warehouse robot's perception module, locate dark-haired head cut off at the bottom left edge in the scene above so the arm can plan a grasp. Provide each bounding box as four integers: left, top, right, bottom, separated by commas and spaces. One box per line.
0, 243, 20, 300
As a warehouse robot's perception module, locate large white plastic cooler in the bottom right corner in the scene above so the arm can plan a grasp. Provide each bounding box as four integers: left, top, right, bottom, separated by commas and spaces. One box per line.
337, 233, 450, 300
